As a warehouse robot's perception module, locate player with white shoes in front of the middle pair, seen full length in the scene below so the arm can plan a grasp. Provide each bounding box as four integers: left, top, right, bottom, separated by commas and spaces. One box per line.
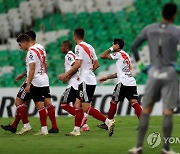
59, 28, 115, 136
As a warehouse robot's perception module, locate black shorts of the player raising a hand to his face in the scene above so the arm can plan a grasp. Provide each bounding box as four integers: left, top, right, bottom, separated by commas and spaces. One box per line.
112, 83, 139, 102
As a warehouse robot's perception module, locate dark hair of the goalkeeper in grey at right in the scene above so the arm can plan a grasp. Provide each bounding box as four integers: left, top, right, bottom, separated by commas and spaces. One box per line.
162, 3, 177, 20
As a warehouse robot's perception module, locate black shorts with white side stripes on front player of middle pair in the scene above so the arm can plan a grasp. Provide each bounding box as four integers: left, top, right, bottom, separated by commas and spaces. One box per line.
77, 82, 96, 103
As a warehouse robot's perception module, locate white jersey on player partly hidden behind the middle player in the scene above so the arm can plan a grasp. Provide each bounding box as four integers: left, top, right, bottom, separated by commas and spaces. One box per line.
64, 51, 79, 90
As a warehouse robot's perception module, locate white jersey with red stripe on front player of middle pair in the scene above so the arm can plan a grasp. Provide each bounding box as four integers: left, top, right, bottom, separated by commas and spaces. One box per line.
75, 42, 97, 85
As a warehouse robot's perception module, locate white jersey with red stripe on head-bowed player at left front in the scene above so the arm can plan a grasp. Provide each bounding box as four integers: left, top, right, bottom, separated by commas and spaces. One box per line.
26, 44, 49, 87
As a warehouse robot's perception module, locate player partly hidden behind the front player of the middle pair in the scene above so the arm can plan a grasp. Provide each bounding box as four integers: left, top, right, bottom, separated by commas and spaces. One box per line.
58, 40, 90, 131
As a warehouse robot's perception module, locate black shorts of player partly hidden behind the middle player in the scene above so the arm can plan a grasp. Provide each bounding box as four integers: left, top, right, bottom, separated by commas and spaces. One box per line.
61, 86, 78, 104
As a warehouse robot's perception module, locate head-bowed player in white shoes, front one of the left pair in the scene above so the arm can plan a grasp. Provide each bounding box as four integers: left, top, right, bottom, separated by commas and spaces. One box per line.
17, 34, 51, 135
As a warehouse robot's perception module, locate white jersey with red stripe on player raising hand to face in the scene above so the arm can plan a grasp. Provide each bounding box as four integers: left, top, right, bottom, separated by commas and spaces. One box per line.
110, 50, 136, 86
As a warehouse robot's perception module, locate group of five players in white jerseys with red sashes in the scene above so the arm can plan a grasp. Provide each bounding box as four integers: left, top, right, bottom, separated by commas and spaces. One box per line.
1, 28, 142, 136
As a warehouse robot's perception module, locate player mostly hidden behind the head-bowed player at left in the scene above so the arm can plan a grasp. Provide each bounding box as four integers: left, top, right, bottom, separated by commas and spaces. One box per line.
1, 30, 59, 135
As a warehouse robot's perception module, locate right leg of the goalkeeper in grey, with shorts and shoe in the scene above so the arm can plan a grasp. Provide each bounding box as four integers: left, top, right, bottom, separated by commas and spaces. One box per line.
161, 79, 179, 154
